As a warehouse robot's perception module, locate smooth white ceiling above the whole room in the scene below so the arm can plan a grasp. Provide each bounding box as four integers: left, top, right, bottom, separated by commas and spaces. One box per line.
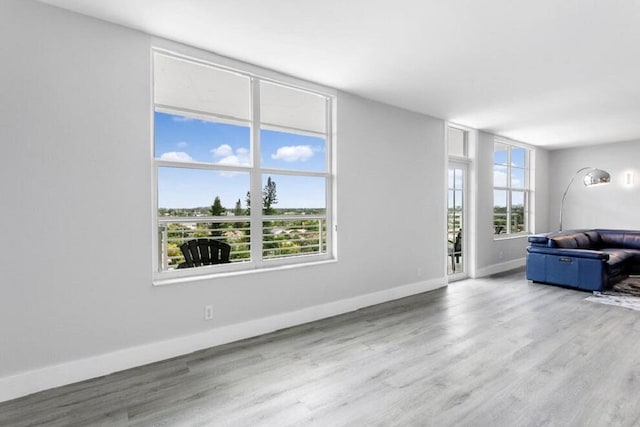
41, 0, 640, 148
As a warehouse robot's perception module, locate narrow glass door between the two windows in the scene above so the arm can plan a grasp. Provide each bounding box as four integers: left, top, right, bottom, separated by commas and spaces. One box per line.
447, 161, 467, 280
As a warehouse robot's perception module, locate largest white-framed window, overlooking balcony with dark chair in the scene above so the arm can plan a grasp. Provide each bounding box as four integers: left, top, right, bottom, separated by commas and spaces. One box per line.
152, 49, 335, 281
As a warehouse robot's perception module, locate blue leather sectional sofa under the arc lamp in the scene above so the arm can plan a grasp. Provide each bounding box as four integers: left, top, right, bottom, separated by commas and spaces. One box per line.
527, 229, 640, 291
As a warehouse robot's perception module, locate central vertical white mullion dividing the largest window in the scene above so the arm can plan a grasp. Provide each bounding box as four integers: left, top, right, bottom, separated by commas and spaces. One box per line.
250, 77, 262, 266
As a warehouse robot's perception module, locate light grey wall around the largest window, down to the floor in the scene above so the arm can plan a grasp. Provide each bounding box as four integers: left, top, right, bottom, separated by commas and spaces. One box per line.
0, 0, 446, 400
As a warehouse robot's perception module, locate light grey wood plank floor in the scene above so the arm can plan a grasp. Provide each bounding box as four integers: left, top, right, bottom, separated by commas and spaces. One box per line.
0, 272, 640, 427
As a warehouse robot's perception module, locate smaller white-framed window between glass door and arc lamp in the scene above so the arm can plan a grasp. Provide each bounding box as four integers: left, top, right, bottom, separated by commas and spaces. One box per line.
493, 138, 531, 237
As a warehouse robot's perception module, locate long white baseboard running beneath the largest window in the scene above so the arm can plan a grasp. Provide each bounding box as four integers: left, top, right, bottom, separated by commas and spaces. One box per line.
0, 277, 445, 402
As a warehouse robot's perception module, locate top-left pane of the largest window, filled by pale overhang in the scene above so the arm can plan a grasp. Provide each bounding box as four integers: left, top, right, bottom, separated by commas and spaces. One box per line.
153, 53, 251, 122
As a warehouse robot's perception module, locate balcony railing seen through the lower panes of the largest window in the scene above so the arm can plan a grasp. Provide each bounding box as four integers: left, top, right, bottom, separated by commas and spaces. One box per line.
158, 215, 327, 271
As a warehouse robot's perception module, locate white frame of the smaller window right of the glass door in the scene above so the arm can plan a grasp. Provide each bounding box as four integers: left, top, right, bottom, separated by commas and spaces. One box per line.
491, 137, 534, 240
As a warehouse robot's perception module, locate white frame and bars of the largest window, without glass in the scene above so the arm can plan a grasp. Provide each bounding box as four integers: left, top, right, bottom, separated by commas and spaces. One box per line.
151, 47, 337, 285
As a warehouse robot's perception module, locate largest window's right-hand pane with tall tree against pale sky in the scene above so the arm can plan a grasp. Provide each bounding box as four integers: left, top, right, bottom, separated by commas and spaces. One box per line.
262, 175, 326, 215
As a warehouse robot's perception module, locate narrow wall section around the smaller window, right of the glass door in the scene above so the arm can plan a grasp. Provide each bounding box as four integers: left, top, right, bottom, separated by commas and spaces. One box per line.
475, 132, 548, 277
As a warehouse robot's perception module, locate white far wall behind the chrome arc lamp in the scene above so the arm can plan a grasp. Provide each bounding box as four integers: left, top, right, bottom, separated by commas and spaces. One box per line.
549, 141, 640, 230
